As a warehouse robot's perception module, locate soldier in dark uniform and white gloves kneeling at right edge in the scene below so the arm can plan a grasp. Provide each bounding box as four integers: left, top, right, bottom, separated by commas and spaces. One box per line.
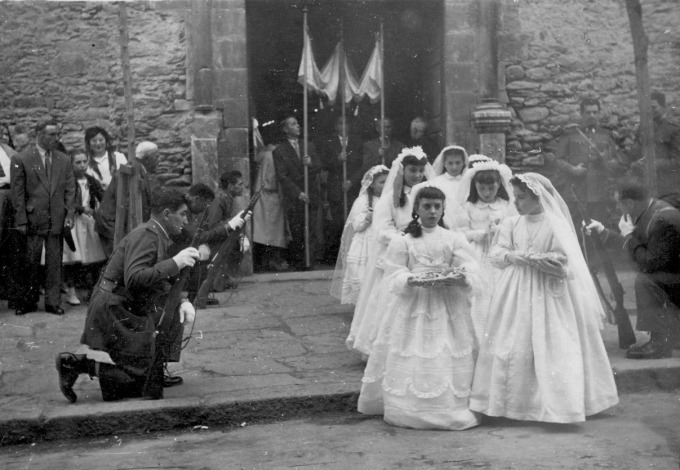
586, 181, 680, 359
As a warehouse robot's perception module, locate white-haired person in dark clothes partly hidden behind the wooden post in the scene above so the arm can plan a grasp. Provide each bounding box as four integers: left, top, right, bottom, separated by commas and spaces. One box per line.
95, 142, 158, 256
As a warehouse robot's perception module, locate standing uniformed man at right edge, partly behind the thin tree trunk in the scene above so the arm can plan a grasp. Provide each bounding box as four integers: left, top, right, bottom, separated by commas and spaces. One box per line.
630, 91, 680, 196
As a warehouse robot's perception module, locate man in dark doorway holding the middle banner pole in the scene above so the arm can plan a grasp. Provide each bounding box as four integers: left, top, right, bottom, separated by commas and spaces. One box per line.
322, 117, 363, 264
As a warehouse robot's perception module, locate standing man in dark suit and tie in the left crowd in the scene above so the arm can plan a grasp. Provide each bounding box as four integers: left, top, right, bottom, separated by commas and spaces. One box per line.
11, 120, 75, 315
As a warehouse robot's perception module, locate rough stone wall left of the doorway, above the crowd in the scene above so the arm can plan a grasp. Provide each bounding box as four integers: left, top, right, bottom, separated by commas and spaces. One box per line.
0, 1, 194, 183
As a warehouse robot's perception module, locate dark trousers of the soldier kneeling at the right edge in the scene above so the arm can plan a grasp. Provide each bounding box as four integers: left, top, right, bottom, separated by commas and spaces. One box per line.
635, 272, 680, 339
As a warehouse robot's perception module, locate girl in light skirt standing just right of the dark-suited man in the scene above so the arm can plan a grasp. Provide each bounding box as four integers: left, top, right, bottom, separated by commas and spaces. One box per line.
62, 151, 106, 305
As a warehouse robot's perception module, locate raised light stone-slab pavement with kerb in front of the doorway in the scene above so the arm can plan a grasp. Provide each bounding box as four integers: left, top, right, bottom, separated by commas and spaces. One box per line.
0, 271, 680, 445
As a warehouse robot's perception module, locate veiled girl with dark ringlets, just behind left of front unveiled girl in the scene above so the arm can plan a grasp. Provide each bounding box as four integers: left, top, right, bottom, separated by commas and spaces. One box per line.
345, 147, 434, 355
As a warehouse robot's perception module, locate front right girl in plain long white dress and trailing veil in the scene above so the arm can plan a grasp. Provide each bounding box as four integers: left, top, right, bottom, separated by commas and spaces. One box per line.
470, 173, 618, 423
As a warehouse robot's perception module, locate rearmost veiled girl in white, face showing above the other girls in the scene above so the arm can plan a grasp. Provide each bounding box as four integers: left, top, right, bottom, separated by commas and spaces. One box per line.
428, 145, 468, 230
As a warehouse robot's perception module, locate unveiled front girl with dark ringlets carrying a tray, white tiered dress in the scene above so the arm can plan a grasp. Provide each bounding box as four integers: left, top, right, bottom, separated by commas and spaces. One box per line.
358, 186, 479, 430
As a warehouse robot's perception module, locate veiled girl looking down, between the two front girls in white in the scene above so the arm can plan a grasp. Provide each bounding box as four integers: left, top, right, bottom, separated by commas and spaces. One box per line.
459, 159, 517, 341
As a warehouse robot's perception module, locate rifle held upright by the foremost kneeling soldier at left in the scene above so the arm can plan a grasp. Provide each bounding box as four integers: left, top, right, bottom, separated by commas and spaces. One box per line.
142, 210, 208, 399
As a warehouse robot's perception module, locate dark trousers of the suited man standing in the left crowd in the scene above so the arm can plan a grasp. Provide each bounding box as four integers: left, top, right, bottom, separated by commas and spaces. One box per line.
24, 234, 64, 306
